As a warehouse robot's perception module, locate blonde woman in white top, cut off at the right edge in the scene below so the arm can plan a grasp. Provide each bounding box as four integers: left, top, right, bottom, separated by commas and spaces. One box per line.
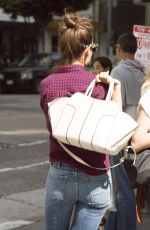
131, 67, 150, 222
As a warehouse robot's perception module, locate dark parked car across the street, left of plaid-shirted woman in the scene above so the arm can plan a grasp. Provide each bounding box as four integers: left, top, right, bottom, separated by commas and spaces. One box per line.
1, 53, 60, 93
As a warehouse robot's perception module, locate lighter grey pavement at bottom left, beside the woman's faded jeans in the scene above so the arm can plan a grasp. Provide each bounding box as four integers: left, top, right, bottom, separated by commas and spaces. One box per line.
0, 189, 150, 230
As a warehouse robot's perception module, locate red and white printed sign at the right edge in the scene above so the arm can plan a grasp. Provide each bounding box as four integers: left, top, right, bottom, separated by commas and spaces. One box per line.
133, 25, 150, 68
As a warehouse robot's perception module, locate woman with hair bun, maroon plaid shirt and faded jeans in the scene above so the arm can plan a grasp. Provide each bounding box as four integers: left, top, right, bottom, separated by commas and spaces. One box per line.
41, 9, 122, 230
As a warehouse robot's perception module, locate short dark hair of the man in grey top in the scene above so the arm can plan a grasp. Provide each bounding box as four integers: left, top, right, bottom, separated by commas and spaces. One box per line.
117, 33, 137, 54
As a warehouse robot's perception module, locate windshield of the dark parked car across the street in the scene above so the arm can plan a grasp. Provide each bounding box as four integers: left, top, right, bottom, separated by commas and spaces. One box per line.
19, 54, 50, 67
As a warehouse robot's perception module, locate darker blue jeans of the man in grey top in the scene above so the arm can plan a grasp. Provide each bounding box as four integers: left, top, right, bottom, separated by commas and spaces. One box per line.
104, 154, 136, 230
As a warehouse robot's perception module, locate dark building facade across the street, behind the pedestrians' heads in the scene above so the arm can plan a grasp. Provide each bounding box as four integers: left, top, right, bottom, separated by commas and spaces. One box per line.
0, 0, 150, 63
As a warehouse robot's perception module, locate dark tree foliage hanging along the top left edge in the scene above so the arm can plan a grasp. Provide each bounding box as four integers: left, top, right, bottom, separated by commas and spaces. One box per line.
0, 0, 93, 24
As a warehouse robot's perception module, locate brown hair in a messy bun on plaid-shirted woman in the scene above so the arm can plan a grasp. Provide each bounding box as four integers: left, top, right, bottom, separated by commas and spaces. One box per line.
59, 10, 93, 64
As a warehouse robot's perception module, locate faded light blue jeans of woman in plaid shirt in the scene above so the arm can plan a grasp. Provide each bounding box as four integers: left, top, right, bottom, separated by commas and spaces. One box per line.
45, 162, 111, 230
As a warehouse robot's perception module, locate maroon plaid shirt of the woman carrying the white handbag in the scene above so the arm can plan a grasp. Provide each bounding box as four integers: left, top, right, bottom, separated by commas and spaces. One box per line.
40, 65, 109, 175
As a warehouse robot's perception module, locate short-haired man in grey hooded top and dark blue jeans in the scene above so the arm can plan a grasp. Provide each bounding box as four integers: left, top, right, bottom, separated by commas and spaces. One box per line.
104, 33, 145, 230
